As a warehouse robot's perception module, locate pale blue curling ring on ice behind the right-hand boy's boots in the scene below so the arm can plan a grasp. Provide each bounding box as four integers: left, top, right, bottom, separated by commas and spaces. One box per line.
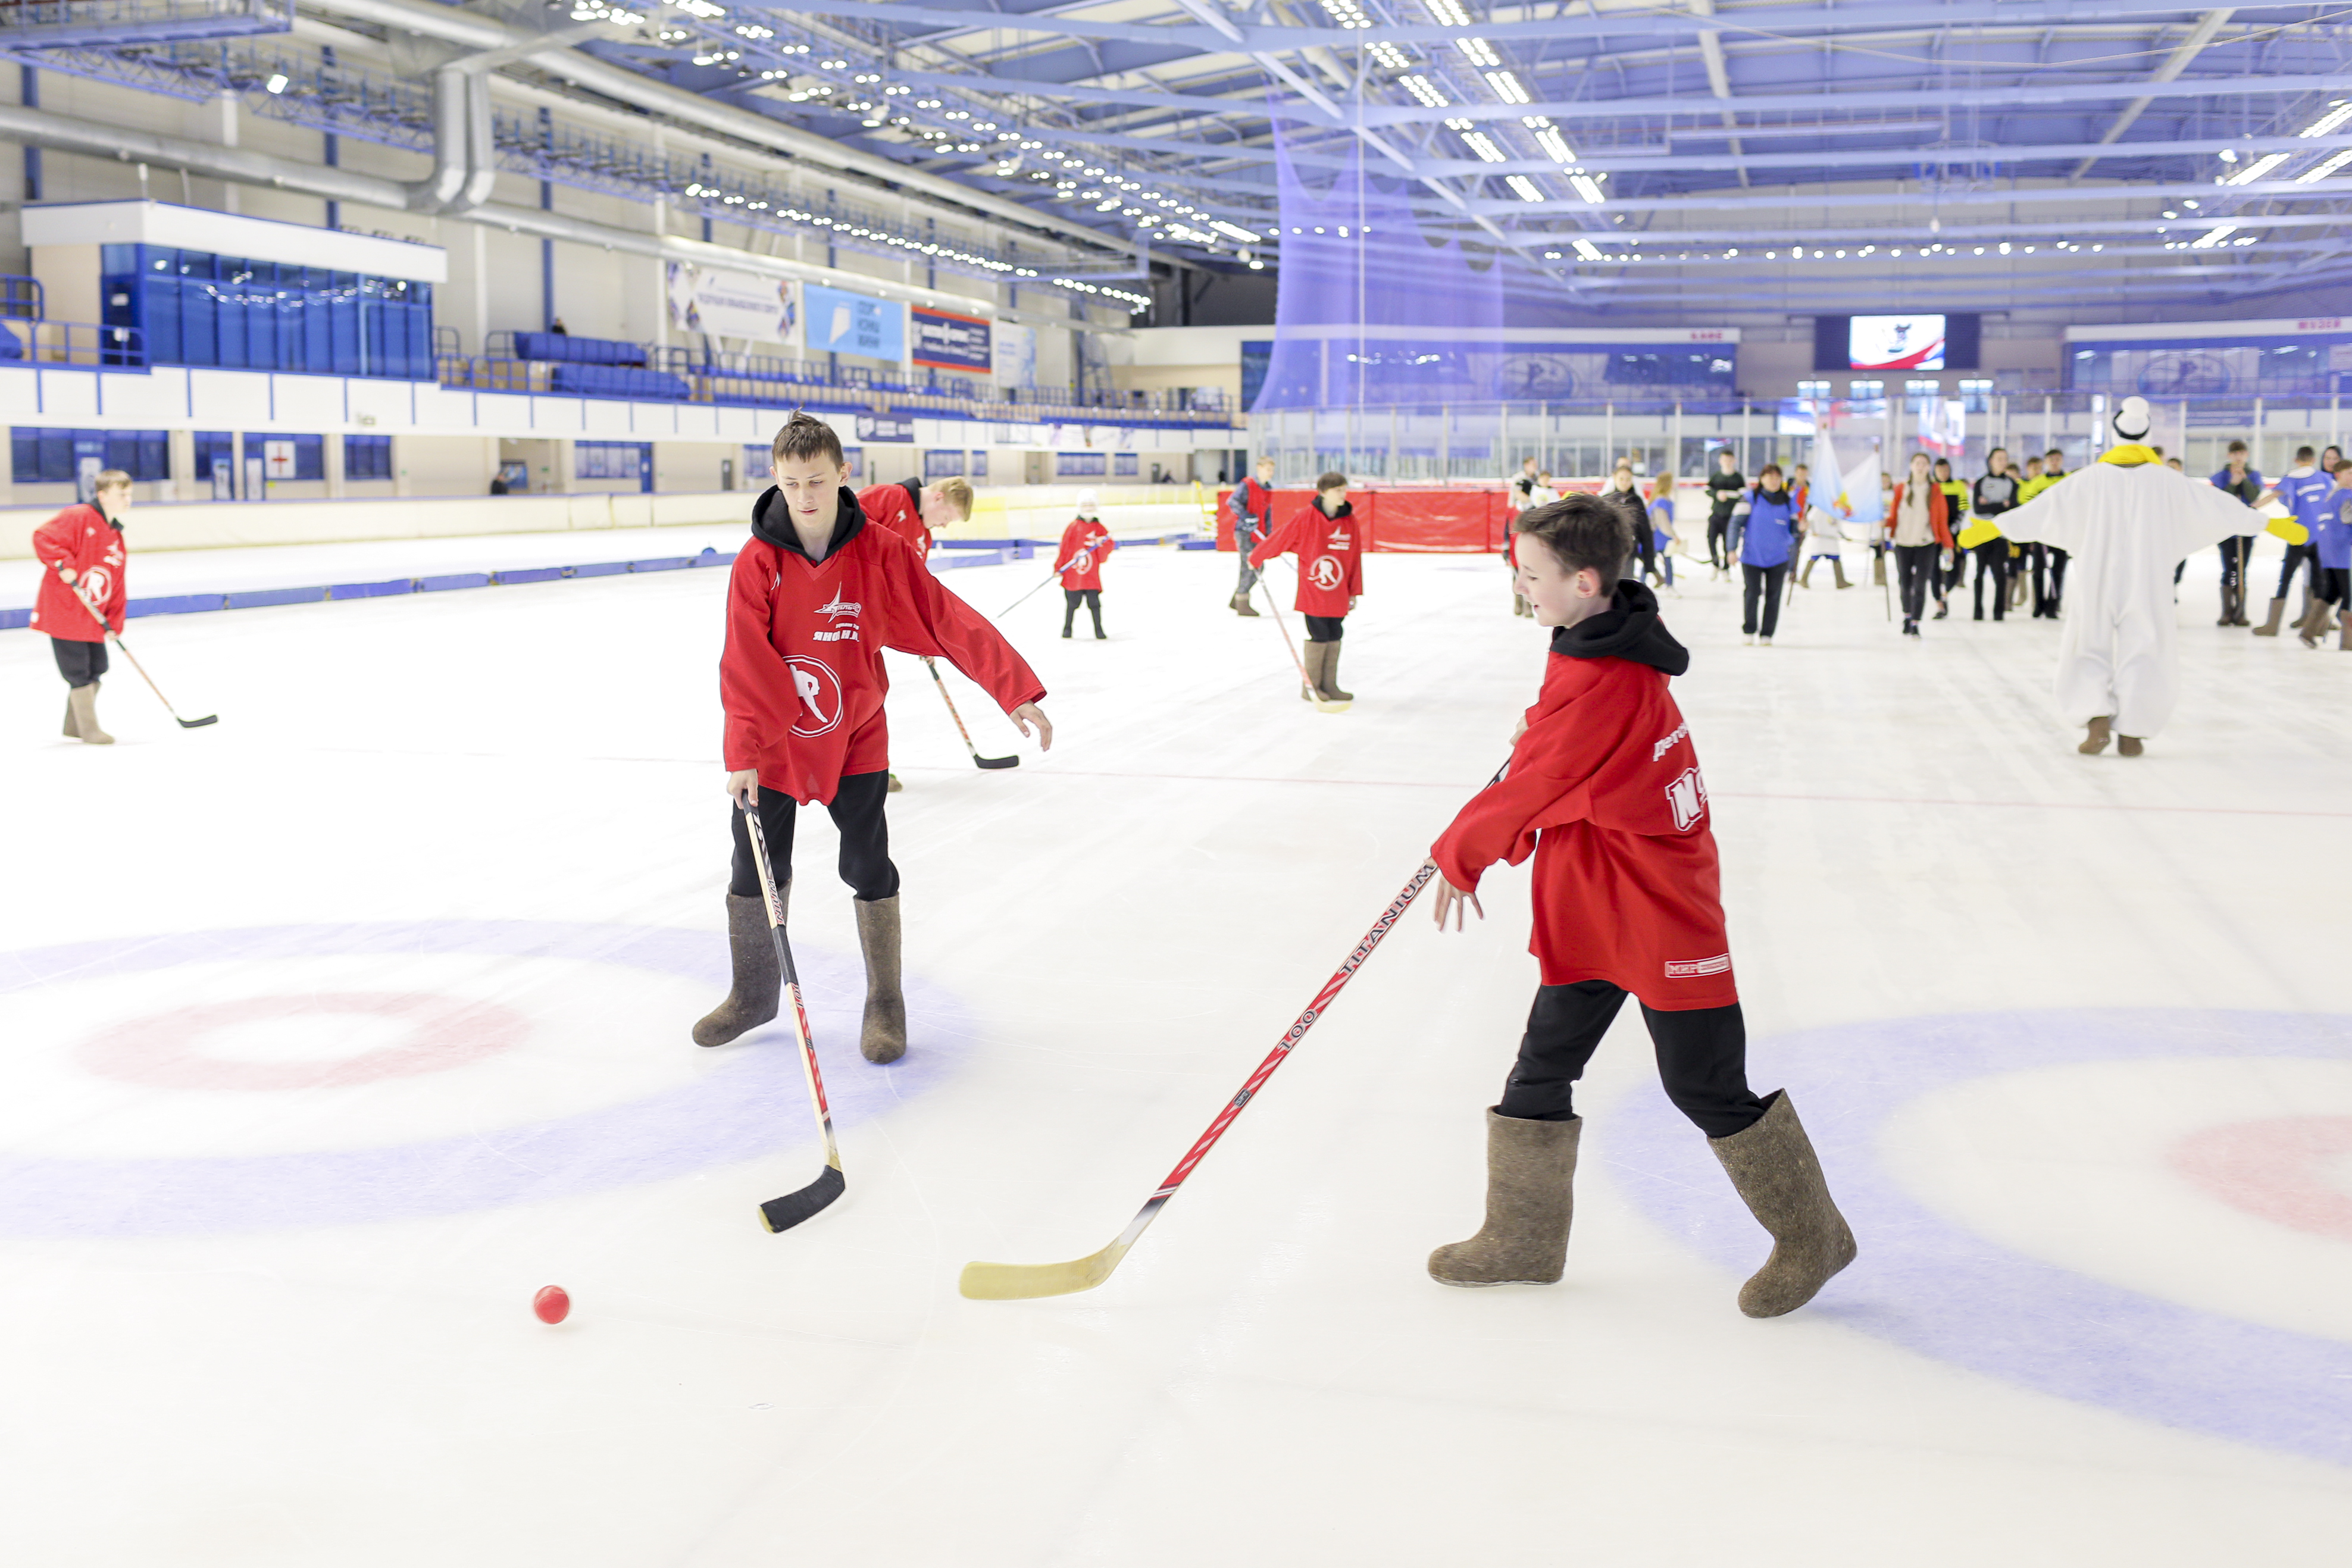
1609, 1009, 2352, 1464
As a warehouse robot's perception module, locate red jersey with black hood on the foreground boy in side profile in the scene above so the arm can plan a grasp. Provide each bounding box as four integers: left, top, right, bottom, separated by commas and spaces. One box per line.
1430, 583, 1740, 1013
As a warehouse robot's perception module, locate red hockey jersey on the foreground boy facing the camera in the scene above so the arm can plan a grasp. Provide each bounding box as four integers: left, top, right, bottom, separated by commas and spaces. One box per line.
720, 489, 1044, 804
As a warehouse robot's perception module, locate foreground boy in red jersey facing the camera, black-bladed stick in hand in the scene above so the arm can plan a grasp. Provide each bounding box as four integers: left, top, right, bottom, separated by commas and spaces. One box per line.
694, 414, 1053, 1063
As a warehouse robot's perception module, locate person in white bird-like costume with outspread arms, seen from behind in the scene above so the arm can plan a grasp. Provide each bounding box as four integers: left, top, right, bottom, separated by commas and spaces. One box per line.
1999, 398, 2263, 757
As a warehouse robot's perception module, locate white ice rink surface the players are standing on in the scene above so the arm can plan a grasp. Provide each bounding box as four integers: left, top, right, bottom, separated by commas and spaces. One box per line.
0, 533, 2352, 1568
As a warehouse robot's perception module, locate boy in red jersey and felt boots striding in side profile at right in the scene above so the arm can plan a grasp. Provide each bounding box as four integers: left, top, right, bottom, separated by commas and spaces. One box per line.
1430, 496, 1853, 1316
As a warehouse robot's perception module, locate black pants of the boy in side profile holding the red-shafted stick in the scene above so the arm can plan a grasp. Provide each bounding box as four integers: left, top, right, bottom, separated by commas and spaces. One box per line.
1496, 980, 1764, 1138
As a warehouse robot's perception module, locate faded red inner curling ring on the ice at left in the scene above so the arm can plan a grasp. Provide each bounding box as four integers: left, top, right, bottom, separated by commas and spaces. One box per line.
75, 992, 531, 1093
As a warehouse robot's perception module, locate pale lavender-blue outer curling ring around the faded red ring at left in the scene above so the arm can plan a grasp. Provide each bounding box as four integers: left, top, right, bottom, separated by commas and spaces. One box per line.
0, 922, 969, 1237
